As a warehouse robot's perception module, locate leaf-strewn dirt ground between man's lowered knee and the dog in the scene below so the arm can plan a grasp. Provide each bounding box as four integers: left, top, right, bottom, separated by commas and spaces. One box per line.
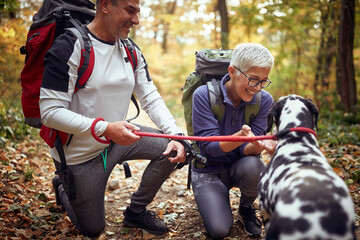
100, 161, 260, 239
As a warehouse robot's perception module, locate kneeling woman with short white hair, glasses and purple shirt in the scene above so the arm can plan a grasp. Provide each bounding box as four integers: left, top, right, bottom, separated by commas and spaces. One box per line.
192, 43, 276, 239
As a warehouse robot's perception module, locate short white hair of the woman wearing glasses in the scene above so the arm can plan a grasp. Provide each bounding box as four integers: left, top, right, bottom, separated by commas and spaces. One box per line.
230, 43, 274, 72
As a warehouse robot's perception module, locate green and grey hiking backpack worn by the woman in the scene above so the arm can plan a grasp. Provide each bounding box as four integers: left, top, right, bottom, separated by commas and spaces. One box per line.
182, 49, 261, 136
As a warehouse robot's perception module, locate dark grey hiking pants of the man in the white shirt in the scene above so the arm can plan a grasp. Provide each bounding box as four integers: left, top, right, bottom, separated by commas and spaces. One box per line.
54, 126, 176, 236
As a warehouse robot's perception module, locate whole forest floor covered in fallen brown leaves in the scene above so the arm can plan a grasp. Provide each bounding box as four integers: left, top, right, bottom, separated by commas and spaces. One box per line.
0, 108, 360, 240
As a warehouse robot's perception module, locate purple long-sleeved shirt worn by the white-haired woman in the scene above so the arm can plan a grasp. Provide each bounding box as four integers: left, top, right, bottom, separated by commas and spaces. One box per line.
192, 74, 273, 172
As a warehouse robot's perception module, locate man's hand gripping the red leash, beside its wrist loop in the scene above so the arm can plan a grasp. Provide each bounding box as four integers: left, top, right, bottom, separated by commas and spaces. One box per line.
103, 121, 141, 146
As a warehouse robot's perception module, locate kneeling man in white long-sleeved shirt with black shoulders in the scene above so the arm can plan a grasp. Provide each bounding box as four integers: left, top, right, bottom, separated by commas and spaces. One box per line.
40, 0, 186, 236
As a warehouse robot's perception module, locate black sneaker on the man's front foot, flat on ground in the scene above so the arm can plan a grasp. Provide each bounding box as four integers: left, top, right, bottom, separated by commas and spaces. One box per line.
124, 208, 168, 235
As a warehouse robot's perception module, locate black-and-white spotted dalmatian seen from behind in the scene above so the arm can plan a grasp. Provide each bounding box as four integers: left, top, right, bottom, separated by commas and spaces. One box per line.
258, 95, 355, 240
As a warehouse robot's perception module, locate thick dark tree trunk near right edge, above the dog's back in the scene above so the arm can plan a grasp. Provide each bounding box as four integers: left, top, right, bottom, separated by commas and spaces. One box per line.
337, 0, 357, 112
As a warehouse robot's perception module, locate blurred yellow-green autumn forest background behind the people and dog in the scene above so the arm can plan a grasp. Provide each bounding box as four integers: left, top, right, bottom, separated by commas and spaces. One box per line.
0, 0, 360, 146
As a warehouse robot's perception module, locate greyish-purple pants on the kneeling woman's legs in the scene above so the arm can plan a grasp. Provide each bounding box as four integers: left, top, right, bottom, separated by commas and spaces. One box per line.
191, 156, 265, 239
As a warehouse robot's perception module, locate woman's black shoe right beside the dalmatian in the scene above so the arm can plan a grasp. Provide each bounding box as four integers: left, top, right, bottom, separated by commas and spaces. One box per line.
239, 206, 262, 237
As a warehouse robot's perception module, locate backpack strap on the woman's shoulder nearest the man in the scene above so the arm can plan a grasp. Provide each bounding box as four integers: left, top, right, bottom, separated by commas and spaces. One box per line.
206, 79, 225, 123
